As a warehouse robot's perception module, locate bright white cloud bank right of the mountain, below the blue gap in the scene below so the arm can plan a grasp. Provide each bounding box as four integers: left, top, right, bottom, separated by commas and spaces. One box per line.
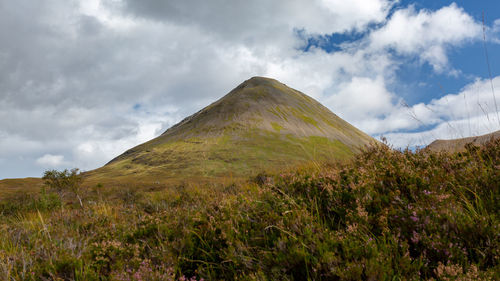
325, 76, 500, 141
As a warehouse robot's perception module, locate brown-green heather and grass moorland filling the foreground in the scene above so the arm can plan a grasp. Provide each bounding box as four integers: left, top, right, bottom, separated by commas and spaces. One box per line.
0, 140, 500, 280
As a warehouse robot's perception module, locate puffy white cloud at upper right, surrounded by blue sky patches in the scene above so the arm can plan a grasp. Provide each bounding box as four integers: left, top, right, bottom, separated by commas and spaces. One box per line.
370, 3, 481, 72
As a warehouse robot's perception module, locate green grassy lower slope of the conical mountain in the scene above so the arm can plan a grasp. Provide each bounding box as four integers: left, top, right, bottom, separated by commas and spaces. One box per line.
86, 130, 354, 186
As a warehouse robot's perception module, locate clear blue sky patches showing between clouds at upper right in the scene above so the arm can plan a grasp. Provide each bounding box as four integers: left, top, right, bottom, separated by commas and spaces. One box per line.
299, 0, 500, 104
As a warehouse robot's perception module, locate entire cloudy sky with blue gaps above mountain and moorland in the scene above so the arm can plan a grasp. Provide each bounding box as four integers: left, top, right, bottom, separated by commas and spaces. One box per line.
0, 0, 500, 179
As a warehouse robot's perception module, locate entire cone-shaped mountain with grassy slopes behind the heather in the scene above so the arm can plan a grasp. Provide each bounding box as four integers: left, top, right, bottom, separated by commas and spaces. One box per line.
87, 77, 374, 184
